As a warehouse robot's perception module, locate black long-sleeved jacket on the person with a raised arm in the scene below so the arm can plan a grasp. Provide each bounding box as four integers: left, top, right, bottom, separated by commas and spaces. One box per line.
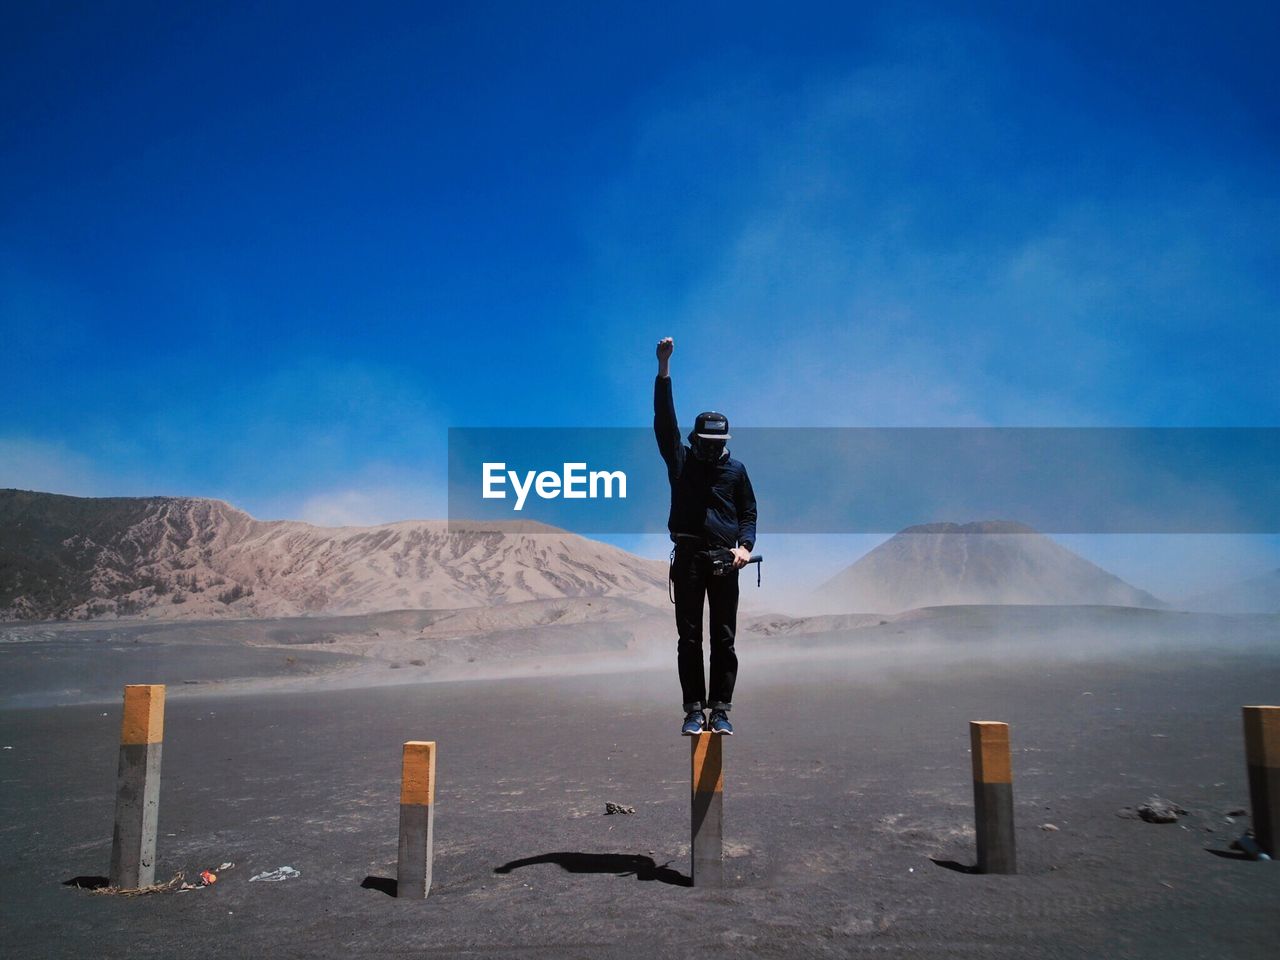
653, 376, 755, 550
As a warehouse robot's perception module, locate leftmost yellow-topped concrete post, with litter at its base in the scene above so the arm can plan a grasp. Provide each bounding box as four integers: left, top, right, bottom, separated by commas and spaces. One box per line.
110, 684, 164, 890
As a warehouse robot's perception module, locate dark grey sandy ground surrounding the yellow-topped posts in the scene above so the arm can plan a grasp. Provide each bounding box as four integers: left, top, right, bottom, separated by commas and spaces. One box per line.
0, 609, 1280, 957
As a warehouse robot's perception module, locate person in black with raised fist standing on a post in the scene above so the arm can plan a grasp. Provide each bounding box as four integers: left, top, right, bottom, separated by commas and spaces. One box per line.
653, 337, 755, 736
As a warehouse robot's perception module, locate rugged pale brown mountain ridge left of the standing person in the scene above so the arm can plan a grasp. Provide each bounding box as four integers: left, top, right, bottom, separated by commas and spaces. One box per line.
0, 489, 667, 620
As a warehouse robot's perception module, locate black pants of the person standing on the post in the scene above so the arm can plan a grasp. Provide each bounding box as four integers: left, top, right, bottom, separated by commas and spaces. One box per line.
671, 541, 737, 712
